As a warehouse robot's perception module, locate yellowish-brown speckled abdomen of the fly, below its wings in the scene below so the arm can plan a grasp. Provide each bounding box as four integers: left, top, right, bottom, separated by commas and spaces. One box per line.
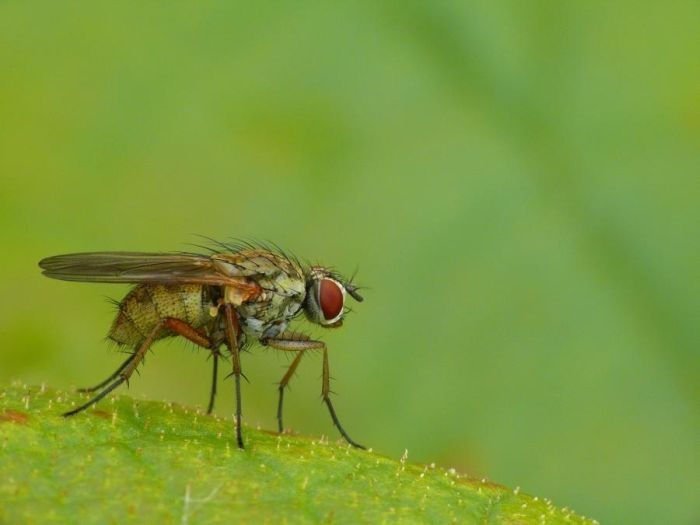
108, 284, 212, 346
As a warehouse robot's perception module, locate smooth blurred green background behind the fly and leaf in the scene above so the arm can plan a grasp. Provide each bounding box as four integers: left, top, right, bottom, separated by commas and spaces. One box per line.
0, 2, 700, 524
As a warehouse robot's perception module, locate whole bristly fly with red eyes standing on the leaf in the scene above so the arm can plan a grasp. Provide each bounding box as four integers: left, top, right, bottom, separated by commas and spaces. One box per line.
39, 239, 365, 448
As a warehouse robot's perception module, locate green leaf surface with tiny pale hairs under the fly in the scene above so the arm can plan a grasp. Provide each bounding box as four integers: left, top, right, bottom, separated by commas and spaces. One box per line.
0, 383, 595, 524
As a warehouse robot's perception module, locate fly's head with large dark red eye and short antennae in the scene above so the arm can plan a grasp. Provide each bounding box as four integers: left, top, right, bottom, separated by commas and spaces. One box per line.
304, 266, 363, 328
